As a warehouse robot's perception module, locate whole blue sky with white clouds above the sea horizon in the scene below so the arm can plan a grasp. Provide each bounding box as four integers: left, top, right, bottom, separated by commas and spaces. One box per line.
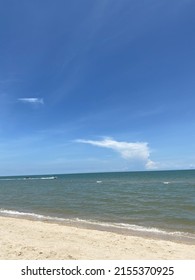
0, 0, 195, 175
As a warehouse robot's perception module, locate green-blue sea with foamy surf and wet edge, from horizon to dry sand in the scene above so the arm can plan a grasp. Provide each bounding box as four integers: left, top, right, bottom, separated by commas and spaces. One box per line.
0, 170, 195, 243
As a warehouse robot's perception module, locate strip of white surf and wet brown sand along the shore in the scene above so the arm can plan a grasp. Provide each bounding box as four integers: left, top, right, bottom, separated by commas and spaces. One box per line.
0, 210, 195, 245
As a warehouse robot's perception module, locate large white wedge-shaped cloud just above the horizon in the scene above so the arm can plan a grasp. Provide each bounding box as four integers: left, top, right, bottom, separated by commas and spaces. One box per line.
76, 138, 157, 169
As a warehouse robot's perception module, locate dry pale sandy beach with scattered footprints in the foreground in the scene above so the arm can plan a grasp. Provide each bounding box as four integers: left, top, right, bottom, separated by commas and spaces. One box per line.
0, 217, 195, 260
